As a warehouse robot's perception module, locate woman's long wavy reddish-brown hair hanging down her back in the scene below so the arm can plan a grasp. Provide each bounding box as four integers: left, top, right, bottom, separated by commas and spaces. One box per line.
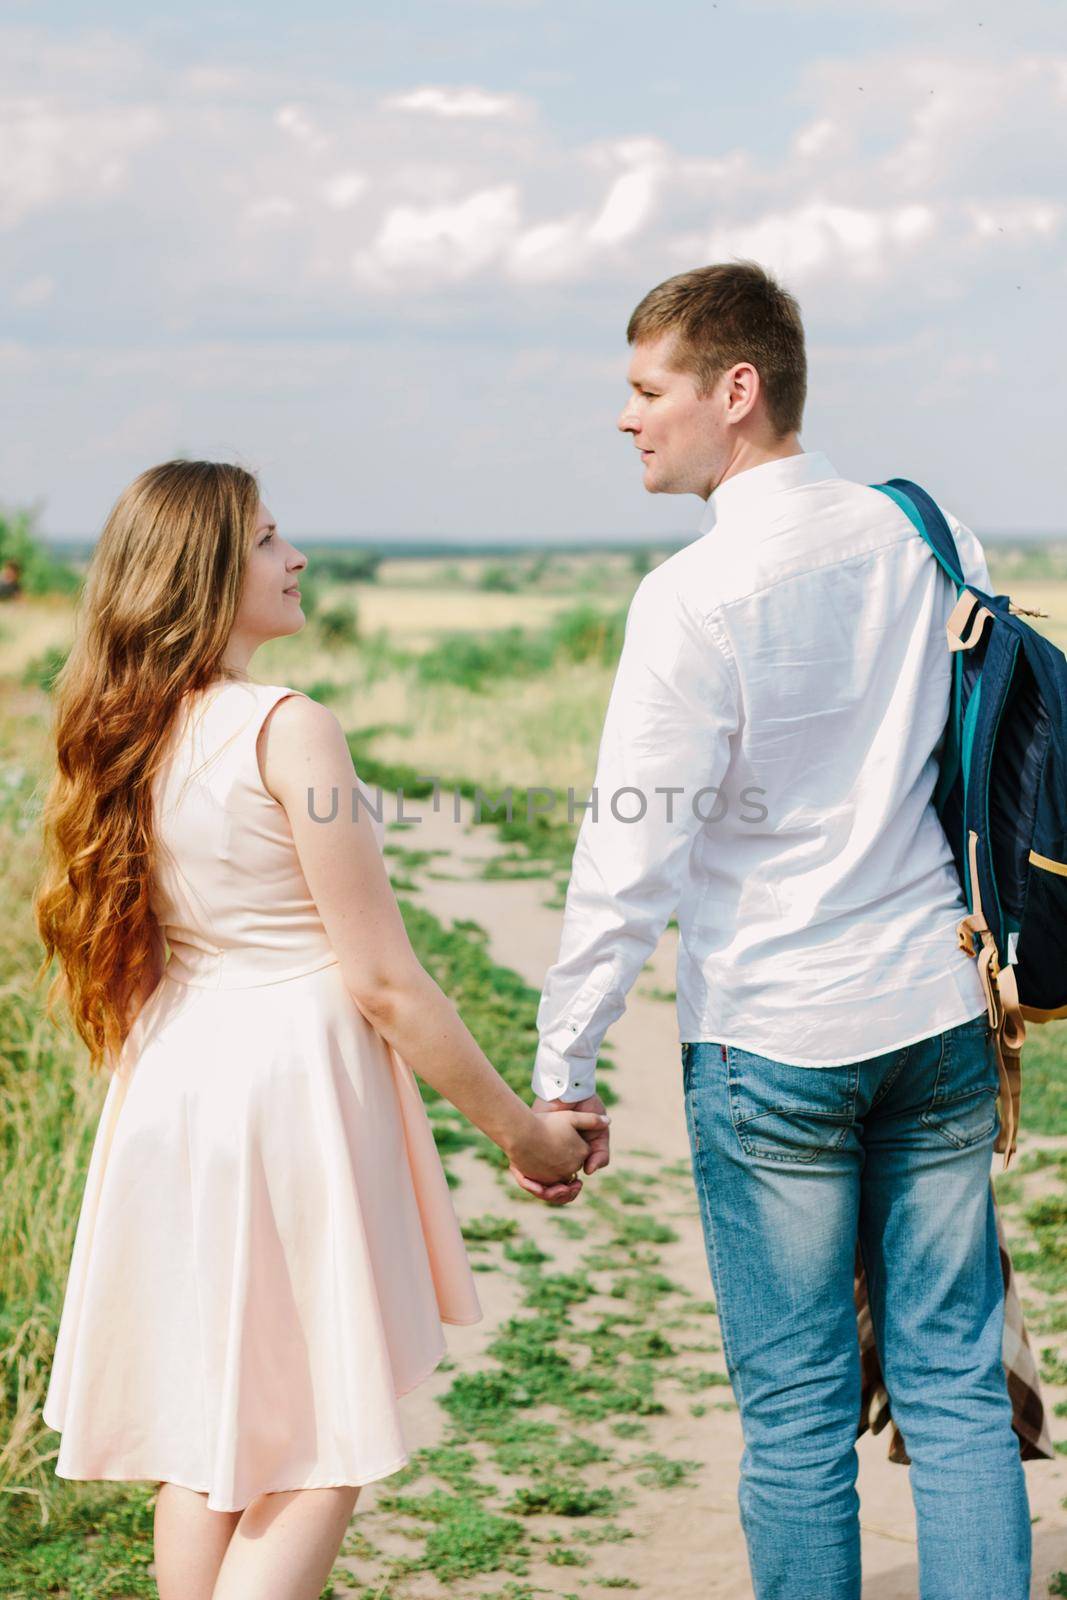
34, 461, 259, 1070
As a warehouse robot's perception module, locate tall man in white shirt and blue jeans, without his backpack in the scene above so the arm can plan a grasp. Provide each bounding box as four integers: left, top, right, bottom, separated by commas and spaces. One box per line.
517, 262, 1030, 1600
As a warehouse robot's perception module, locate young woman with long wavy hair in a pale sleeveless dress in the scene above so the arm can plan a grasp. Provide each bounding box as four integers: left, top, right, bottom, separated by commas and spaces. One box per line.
35, 461, 606, 1600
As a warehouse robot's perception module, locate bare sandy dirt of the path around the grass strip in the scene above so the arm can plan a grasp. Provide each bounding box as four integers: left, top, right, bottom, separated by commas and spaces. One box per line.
347, 806, 1067, 1600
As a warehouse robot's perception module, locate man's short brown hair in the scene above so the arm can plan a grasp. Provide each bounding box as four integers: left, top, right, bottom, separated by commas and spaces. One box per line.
625, 261, 808, 438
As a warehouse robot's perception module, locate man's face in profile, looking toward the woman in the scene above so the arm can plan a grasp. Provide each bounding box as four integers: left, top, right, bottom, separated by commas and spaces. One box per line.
617, 333, 733, 499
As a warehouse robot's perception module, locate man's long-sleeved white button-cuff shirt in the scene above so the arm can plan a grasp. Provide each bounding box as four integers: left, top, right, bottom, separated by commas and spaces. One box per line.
533, 451, 992, 1101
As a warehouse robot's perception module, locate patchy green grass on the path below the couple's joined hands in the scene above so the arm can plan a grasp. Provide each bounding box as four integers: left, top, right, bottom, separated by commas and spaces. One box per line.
343, 1186, 710, 1595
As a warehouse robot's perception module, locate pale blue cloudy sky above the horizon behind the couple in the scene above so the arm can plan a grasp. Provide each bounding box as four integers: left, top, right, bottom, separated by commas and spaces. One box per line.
0, 0, 1067, 539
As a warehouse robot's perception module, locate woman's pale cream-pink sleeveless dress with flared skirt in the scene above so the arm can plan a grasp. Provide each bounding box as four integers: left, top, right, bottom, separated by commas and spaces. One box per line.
43, 682, 482, 1510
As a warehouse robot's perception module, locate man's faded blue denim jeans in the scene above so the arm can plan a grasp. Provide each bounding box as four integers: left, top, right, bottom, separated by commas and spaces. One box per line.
681, 1013, 1030, 1600
